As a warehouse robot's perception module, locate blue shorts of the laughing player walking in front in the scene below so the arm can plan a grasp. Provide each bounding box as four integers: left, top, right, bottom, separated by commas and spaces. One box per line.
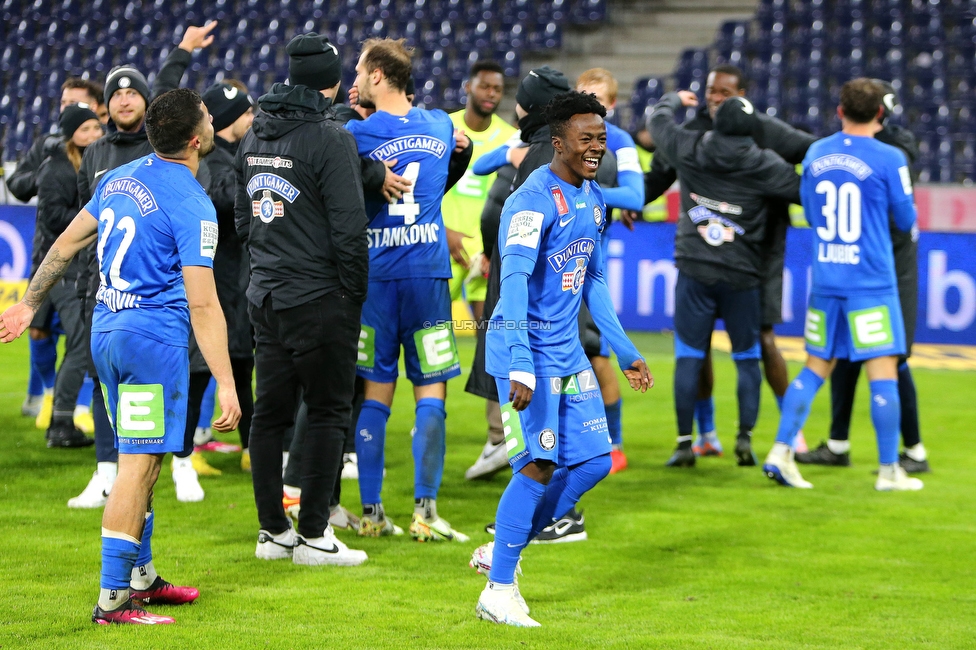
495, 369, 610, 472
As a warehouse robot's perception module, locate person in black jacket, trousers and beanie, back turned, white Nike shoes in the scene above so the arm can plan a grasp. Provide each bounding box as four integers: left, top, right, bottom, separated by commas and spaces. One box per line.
235, 33, 369, 565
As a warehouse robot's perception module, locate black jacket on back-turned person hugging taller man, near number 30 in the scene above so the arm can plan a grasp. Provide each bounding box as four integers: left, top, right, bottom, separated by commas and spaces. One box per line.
649, 93, 800, 289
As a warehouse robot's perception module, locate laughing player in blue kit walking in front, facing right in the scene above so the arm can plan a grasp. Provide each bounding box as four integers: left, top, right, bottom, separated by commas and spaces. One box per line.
472, 92, 653, 627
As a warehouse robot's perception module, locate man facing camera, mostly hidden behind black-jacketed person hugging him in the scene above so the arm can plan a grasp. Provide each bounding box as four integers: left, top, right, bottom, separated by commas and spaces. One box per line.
644, 65, 816, 454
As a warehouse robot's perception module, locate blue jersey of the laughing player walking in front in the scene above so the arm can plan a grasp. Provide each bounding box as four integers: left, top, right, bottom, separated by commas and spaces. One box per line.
485, 165, 606, 374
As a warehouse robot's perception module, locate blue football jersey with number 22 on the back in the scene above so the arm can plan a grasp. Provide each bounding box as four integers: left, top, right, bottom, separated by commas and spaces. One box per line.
85, 154, 217, 347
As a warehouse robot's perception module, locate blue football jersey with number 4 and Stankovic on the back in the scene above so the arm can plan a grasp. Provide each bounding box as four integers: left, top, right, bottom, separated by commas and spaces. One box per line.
346, 108, 455, 280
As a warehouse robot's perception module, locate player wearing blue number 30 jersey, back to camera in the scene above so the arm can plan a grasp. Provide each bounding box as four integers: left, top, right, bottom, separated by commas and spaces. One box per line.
763, 78, 923, 491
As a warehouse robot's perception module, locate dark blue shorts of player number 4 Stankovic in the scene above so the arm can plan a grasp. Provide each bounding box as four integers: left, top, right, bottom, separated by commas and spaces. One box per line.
356, 278, 461, 386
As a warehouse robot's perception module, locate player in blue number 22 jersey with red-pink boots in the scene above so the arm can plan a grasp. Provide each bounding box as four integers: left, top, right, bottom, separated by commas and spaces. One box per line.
0, 89, 241, 625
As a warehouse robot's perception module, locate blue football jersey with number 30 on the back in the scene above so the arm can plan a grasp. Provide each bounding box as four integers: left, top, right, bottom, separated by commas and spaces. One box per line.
800, 132, 915, 296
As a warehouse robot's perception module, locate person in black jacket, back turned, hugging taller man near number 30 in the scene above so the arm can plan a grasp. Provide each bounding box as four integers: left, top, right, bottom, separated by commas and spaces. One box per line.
649, 91, 800, 465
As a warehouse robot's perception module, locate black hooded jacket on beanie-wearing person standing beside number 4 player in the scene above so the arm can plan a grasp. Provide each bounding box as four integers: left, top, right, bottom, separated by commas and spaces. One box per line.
235, 84, 369, 309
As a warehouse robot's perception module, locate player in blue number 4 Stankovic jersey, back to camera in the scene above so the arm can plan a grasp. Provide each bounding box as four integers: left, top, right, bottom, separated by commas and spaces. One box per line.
346, 39, 468, 542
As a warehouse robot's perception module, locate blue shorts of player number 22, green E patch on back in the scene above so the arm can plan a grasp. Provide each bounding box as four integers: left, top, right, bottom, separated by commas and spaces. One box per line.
91, 330, 190, 454
